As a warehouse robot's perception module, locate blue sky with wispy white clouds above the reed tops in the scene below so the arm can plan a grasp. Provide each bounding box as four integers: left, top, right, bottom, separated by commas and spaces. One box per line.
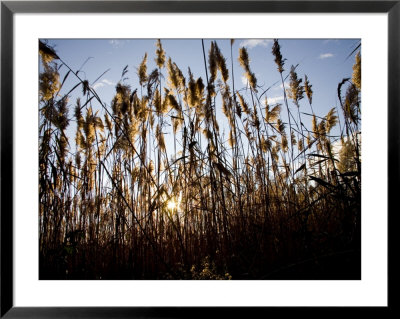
42, 39, 360, 160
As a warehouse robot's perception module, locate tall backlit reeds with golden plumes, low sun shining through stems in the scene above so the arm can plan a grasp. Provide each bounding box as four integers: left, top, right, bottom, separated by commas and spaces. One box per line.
38, 40, 361, 279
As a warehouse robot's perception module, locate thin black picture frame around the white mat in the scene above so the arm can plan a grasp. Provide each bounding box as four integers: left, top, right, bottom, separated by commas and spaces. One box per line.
0, 0, 394, 318
